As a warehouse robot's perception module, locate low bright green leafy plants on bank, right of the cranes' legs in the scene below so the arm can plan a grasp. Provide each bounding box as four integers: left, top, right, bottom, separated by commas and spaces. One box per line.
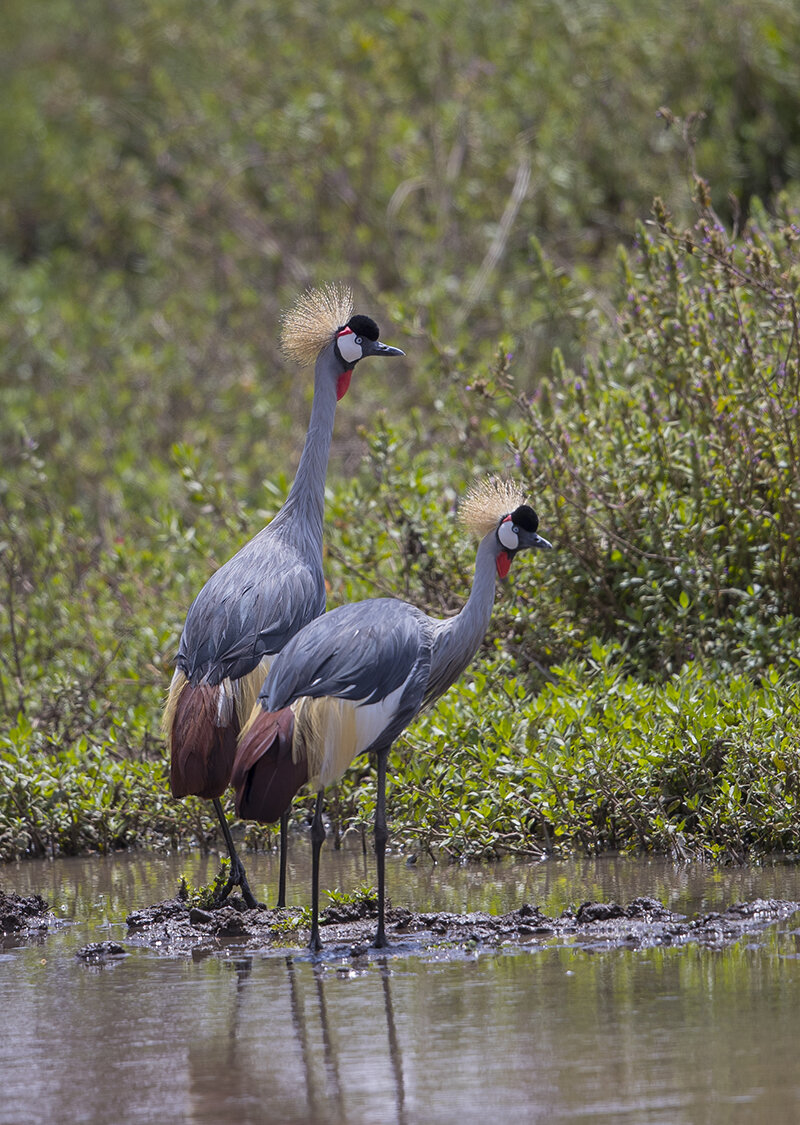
342, 645, 800, 862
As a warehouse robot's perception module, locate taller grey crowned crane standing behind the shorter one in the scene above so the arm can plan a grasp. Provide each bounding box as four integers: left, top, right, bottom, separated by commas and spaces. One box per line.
162, 286, 403, 907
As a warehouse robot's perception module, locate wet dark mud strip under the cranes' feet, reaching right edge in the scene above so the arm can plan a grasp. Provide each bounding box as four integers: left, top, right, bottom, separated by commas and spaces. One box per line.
127, 898, 800, 957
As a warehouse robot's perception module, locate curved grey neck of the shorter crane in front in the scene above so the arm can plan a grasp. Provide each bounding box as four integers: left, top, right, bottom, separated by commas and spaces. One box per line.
426, 531, 497, 702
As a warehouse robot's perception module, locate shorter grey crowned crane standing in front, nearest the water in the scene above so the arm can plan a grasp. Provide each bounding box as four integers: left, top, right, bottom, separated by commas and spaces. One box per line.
231, 478, 551, 951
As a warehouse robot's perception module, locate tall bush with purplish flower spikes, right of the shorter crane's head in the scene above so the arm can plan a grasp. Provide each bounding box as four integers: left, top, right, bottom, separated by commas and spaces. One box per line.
512, 189, 800, 673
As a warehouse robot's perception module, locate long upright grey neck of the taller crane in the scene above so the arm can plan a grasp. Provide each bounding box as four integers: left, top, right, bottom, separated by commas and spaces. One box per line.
270, 344, 340, 555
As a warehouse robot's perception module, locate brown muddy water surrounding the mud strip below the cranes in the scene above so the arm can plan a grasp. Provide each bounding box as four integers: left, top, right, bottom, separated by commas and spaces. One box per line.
0, 845, 800, 1125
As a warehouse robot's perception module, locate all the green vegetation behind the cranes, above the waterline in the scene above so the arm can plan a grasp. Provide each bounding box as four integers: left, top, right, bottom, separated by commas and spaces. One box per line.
0, 0, 800, 860
